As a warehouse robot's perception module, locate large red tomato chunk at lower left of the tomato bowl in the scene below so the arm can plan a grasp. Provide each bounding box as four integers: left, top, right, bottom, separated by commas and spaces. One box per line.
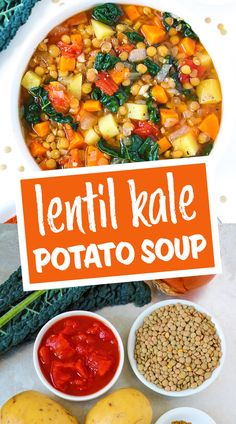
50, 361, 74, 389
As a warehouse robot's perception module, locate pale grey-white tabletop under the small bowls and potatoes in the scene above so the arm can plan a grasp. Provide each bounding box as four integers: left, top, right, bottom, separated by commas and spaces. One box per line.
0, 225, 236, 424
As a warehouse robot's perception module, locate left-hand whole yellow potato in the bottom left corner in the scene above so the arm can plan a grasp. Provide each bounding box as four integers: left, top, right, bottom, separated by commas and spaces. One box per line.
0, 390, 78, 424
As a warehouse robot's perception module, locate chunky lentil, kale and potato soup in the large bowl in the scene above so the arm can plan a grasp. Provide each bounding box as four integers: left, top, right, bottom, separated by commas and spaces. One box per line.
20, 3, 222, 170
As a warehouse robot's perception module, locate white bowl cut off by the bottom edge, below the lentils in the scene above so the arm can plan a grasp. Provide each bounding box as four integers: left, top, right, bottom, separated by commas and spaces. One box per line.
155, 407, 216, 424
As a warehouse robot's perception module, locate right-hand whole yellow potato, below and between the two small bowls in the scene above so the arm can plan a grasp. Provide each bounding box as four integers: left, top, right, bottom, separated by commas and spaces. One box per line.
85, 388, 152, 424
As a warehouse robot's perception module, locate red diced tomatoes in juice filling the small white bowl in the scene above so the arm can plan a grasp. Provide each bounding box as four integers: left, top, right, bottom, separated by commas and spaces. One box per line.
38, 316, 120, 396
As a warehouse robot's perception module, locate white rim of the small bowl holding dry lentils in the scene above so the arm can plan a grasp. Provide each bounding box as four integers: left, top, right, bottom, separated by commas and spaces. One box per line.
128, 299, 226, 397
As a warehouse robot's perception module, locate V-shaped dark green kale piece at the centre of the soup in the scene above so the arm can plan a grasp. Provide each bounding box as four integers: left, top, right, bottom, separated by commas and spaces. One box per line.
91, 87, 130, 113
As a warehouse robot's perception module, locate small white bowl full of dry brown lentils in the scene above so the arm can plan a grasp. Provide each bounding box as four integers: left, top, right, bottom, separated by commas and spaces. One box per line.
128, 299, 226, 397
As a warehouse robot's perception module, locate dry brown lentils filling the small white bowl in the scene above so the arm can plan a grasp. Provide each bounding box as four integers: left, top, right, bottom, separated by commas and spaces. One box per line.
135, 304, 222, 391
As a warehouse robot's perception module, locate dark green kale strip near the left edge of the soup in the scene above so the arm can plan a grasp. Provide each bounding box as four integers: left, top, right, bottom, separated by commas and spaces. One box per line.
29, 87, 77, 130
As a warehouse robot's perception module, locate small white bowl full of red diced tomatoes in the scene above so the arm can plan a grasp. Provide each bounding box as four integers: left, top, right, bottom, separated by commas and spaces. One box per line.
33, 311, 124, 401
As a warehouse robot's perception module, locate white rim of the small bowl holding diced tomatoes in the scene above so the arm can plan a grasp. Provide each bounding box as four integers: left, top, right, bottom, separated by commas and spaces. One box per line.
33, 311, 124, 402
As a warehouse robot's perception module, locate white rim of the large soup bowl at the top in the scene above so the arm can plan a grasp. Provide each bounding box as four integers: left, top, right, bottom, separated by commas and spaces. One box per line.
10, 0, 234, 171
